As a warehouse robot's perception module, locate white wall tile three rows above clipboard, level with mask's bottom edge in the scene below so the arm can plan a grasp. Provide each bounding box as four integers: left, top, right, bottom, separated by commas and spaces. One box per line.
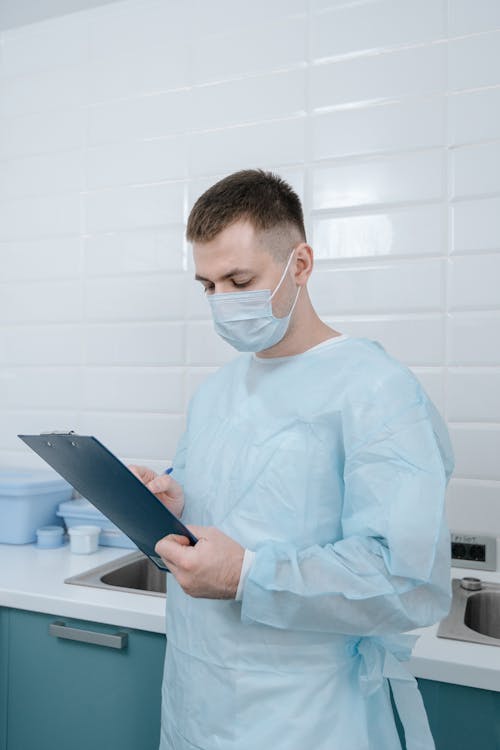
84, 323, 185, 367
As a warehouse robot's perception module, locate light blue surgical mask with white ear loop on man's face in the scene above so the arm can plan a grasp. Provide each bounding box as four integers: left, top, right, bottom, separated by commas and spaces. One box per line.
208, 250, 301, 352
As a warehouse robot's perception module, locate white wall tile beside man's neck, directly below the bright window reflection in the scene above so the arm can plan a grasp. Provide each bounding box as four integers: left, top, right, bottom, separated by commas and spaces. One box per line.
309, 260, 444, 316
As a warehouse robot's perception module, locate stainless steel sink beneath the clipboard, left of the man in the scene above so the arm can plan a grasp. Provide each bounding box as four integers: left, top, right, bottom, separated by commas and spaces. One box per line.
64, 552, 167, 597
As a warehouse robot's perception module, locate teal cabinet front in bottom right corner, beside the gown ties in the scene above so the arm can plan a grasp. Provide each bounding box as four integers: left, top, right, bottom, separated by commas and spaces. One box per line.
397, 679, 500, 750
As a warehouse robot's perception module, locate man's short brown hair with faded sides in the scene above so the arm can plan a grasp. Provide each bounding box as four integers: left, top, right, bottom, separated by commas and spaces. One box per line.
186, 169, 306, 248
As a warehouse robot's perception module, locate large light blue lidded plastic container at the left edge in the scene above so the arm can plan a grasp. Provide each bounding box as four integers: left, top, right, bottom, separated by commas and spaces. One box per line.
0, 469, 73, 544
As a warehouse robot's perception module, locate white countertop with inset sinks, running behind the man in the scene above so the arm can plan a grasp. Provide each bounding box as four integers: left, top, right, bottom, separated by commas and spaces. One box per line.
0, 544, 500, 692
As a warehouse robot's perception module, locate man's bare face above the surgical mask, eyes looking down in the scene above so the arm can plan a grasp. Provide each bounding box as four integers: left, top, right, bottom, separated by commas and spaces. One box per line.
193, 221, 296, 317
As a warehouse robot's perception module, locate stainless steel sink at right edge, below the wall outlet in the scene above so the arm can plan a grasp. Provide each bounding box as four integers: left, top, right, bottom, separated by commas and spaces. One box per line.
437, 578, 500, 646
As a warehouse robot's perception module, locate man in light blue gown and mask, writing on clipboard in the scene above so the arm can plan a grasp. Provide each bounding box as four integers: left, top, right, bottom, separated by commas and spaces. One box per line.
129, 170, 452, 750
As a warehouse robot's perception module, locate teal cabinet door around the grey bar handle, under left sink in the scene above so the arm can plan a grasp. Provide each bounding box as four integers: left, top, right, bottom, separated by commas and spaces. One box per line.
7, 610, 165, 750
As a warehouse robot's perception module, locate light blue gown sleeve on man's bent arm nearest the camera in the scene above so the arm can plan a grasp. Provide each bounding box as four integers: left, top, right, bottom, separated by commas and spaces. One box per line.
241, 372, 453, 636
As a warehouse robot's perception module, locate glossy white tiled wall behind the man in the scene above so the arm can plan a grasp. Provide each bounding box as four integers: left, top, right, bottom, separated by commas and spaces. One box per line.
0, 0, 500, 534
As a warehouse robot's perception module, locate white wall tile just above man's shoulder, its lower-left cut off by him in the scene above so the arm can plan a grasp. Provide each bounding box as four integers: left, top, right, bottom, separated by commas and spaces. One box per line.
326, 315, 445, 366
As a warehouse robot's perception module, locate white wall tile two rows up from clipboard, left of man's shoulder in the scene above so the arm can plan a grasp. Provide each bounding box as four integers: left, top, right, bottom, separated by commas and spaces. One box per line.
83, 367, 184, 414
